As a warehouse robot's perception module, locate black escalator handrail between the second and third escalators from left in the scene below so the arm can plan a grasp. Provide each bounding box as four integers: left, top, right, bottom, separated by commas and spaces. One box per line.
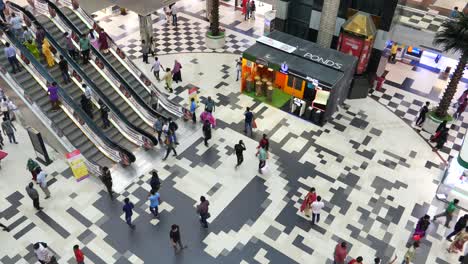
8, 2, 159, 146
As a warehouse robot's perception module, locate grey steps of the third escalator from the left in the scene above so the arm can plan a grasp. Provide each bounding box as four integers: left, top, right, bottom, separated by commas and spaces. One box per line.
37, 15, 157, 138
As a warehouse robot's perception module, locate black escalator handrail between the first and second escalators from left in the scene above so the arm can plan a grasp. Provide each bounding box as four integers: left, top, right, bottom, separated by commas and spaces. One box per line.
5, 5, 135, 163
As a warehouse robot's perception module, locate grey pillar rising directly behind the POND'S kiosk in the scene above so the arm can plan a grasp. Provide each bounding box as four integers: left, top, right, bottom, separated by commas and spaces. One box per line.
317, 0, 340, 48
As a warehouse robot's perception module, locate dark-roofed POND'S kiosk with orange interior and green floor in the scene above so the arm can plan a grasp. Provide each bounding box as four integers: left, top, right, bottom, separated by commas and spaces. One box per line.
241, 31, 357, 125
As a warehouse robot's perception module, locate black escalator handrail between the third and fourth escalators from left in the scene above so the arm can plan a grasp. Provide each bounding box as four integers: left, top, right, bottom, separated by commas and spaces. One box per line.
45, 0, 168, 119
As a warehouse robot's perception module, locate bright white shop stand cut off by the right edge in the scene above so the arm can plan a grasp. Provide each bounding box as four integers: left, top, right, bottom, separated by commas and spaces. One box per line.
437, 137, 468, 210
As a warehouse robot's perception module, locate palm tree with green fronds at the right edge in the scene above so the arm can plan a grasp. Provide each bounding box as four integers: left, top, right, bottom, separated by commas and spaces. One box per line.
433, 13, 468, 118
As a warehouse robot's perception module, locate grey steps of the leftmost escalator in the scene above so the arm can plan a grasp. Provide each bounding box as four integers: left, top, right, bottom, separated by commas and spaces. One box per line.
0, 39, 115, 167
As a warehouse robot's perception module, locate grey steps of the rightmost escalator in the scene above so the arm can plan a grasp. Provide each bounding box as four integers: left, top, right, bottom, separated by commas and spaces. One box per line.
60, 7, 176, 117
